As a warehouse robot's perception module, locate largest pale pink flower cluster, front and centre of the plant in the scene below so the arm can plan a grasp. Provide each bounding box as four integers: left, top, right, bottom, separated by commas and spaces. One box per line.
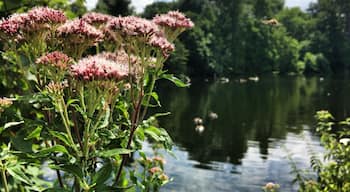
71, 55, 129, 81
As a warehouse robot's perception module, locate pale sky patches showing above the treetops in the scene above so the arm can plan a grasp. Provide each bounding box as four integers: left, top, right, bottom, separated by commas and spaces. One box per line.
86, 0, 316, 13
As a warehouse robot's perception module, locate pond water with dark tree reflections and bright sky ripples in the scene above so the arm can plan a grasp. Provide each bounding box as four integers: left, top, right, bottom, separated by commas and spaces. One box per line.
146, 77, 350, 192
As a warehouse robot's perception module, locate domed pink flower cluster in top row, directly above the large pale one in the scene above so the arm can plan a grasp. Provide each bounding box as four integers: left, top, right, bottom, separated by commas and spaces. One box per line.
57, 19, 103, 43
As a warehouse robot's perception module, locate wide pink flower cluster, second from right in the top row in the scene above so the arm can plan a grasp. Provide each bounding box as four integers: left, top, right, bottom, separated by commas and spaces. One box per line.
106, 16, 159, 36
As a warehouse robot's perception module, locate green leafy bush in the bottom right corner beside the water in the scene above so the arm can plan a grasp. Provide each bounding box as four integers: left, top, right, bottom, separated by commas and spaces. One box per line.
290, 111, 350, 192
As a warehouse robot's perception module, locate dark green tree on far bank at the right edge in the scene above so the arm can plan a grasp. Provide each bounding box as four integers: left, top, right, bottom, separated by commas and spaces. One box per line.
310, 0, 350, 71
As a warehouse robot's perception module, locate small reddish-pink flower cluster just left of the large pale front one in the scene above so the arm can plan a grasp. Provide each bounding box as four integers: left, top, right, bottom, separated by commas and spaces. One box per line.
36, 51, 73, 70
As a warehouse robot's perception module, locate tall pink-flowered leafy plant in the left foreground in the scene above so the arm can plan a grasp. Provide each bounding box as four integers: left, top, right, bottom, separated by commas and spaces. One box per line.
0, 7, 193, 192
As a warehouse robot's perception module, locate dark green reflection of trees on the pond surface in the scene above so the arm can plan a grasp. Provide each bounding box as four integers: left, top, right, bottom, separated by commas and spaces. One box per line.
157, 78, 318, 164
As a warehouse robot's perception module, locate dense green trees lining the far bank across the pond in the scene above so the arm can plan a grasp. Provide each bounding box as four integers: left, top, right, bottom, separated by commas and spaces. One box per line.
143, 0, 350, 76
